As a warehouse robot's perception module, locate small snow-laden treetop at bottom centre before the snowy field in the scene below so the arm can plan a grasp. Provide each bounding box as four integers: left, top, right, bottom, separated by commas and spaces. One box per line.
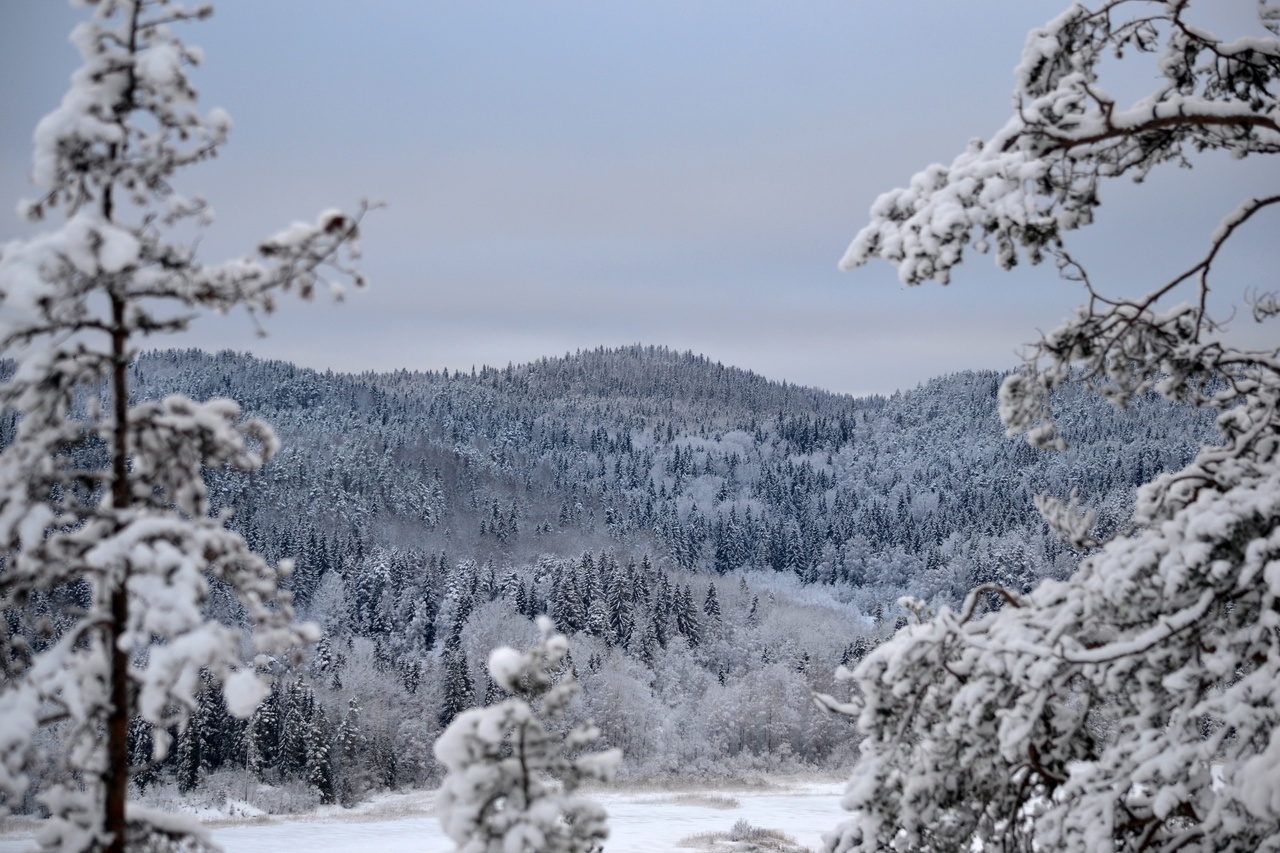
435, 616, 622, 853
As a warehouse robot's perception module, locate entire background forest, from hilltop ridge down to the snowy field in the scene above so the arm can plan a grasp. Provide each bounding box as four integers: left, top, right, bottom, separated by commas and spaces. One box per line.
24, 346, 1212, 811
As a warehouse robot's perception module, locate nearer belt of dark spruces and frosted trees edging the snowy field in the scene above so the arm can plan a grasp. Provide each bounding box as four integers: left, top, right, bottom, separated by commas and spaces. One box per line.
131, 549, 870, 808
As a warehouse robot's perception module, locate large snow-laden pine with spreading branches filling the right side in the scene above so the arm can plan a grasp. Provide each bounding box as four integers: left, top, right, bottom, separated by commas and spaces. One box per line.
828, 0, 1280, 852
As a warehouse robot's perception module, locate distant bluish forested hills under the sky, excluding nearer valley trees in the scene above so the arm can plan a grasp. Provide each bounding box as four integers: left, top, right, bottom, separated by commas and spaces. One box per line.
134, 346, 1208, 603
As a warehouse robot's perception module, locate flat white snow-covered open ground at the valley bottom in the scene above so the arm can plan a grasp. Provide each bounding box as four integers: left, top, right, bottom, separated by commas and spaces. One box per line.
0, 780, 847, 853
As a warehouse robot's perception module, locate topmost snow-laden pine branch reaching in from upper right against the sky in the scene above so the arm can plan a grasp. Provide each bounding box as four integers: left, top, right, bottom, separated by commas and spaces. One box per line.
841, 0, 1280, 284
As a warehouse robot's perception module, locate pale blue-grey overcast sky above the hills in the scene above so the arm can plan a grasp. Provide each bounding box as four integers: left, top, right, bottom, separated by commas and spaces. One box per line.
0, 0, 1280, 393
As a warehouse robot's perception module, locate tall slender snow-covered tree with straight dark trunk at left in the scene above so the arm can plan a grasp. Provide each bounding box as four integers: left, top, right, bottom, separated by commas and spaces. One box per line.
0, 0, 362, 852
